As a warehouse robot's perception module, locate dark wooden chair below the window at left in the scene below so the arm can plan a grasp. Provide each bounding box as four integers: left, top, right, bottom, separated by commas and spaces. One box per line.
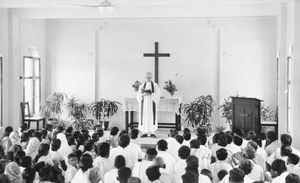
20, 102, 46, 129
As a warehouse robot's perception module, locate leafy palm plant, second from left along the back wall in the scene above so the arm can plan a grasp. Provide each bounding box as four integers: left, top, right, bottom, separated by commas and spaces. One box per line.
67, 97, 93, 130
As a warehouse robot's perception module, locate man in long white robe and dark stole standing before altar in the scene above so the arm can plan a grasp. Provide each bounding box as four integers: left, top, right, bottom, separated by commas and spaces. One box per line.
137, 72, 160, 138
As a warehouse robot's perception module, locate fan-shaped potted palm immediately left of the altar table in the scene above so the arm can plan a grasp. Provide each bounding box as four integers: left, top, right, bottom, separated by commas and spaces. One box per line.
90, 99, 121, 130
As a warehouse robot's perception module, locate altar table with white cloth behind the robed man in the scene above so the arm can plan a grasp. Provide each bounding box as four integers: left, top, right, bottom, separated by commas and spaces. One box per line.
122, 98, 182, 130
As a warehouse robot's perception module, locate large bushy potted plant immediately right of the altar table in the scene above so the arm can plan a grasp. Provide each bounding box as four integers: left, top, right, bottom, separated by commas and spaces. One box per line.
183, 95, 215, 127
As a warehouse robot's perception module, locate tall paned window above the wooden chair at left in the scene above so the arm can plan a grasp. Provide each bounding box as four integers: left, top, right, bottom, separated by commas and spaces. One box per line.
23, 56, 41, 114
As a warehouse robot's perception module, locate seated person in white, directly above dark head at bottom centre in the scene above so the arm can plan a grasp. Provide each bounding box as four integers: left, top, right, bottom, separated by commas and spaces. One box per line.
132, 148, 157, 183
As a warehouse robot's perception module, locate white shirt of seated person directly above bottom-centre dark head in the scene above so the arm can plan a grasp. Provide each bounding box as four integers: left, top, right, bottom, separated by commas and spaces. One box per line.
132, 160, 153, 183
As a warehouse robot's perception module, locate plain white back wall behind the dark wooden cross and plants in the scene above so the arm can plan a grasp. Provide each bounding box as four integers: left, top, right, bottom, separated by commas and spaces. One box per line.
46, 18, 276, 127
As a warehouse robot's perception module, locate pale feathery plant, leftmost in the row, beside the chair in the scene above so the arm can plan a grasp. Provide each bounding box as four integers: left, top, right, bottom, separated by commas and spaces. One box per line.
40, 93, 67, 122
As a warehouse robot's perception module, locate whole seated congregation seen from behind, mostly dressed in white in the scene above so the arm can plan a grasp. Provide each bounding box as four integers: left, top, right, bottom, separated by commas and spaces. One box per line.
0, 125, 300, 183
